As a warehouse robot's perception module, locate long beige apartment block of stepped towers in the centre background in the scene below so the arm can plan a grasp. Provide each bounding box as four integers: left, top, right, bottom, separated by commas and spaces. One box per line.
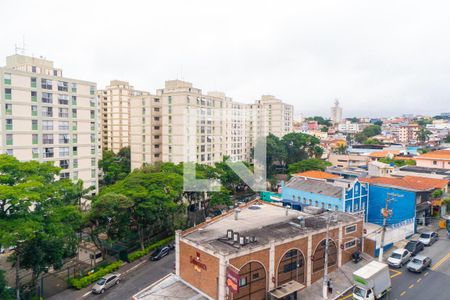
130, 80, 293, 169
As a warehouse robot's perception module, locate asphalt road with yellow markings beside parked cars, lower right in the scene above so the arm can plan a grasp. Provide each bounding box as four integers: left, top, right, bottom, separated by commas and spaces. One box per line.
340, 235, 450, 300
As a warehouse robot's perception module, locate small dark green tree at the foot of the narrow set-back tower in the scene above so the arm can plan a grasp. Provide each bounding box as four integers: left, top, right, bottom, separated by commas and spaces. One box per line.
98, 147, 131, 186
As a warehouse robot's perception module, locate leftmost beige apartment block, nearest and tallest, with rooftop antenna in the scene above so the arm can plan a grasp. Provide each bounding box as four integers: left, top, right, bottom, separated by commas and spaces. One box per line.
0, 54, 99, 192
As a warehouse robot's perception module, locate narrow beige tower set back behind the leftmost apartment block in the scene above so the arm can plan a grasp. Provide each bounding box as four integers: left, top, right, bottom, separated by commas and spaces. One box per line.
98, 80, 150, 153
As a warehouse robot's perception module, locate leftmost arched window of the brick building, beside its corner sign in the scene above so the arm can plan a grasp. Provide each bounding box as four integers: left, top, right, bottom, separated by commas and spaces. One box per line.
233, 261, 267, 300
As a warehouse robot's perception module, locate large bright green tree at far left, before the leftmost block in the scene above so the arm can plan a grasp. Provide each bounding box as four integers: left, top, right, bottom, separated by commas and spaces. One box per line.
0, 155, 81, 293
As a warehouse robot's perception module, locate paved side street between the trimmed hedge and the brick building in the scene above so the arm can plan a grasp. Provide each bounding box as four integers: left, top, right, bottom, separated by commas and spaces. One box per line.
50, 253, 175, 300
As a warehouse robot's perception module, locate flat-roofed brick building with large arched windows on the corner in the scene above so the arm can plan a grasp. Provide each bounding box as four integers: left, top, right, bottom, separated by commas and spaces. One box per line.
172, 202, 363, 300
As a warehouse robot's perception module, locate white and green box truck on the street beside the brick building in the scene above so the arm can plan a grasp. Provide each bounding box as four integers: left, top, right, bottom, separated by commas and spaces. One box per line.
353, 261, 391, 300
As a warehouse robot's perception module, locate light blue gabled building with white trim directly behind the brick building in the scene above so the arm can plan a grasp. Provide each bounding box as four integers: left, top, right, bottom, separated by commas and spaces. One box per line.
281, 177, 368, 216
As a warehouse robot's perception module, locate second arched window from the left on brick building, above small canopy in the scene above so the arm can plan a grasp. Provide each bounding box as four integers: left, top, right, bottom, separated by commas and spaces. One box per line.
277, 249, 305, 286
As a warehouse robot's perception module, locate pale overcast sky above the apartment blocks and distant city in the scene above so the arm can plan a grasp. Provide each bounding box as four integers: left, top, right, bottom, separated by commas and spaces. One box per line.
0, 0, 450, 117
